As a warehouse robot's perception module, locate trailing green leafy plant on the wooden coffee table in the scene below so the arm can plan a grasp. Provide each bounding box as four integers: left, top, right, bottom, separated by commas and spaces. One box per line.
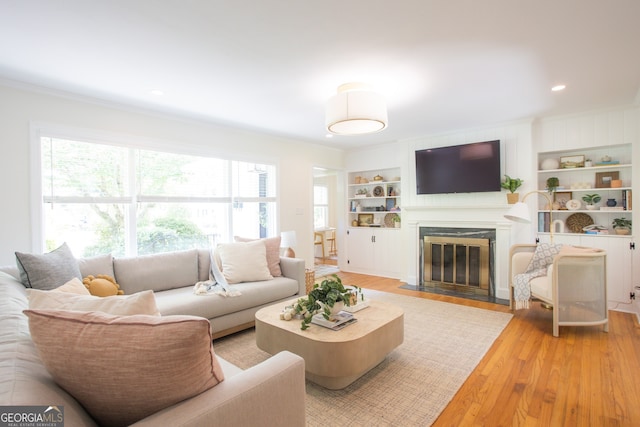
293, 274, 364, 331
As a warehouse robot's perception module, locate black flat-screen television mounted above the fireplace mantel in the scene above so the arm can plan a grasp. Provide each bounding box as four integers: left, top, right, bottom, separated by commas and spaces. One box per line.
416, 140, 502, 194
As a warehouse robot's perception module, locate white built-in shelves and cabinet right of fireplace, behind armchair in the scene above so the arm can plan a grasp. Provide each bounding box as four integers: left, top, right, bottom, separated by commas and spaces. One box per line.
537, 144, 640, 303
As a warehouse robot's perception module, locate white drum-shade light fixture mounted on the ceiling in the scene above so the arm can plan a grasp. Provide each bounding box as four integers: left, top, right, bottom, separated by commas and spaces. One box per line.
325, 83, 387, 135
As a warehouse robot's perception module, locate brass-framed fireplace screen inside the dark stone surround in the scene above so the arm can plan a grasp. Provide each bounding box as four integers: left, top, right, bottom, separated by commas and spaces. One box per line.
423, 236, 489, 295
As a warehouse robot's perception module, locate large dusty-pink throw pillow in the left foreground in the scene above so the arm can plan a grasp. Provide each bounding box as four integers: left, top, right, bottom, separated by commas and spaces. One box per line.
24, 310, 224, 426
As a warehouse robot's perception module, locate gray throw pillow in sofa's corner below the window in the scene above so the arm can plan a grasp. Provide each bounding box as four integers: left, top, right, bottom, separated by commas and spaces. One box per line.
16, 243, 82, 290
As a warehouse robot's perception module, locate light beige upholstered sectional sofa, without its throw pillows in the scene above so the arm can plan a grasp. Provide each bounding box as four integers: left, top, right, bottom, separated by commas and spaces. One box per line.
0, 251, 305, 426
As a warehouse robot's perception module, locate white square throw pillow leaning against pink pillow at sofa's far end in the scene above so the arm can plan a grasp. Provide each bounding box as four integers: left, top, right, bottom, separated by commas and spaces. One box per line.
216, 240, 273, 283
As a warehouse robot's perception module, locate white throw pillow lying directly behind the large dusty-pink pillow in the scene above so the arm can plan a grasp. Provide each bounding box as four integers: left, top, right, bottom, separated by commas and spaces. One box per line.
27, 289, 160, 316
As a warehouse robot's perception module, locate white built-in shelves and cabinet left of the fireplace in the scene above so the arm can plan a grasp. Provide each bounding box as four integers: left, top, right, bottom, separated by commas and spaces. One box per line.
343, 168, 402, 278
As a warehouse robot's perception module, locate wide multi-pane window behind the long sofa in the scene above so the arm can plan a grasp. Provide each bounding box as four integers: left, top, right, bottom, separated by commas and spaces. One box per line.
40, 137, 277, 256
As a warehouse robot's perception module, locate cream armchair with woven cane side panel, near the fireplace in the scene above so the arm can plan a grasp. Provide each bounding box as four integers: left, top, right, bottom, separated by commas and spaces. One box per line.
509, 244, 609, 337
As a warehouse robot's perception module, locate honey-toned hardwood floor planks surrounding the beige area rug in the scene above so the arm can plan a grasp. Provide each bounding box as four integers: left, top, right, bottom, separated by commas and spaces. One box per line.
339, 272, 640, 426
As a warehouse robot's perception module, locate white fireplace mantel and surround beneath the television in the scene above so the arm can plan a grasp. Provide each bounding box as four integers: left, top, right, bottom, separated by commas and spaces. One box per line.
402, 206, 513, 300
